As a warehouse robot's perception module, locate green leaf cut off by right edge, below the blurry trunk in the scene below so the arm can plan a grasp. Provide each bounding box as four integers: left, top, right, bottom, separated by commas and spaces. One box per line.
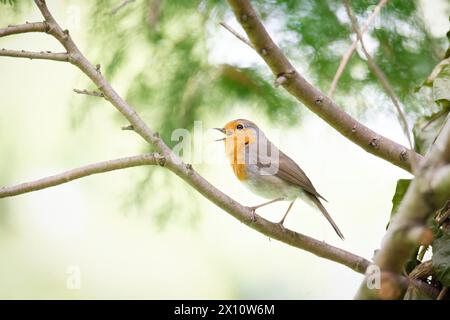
432, 233, 450, 287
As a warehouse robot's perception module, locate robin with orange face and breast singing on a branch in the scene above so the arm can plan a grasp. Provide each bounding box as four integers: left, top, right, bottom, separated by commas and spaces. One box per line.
214, 119, 344, 240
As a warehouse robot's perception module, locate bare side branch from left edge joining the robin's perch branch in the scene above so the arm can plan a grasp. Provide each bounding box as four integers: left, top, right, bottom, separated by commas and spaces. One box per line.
0, 154, 164, 198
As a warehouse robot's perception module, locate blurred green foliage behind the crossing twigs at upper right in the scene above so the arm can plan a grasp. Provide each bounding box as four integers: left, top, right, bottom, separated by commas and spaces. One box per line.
253, 0, 444, 112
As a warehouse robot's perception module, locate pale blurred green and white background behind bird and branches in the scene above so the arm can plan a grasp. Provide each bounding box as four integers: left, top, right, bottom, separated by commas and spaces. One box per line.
0, 0, 450, 299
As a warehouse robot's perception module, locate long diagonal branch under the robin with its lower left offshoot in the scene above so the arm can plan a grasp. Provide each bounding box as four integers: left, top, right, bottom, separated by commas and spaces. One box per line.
0, 0, 436, 296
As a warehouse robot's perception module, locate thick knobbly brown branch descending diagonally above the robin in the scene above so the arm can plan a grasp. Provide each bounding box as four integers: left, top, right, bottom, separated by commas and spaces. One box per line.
228, 0, 422, 172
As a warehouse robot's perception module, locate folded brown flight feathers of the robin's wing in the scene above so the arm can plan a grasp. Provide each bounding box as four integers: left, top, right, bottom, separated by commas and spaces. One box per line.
275, 150, 327, 201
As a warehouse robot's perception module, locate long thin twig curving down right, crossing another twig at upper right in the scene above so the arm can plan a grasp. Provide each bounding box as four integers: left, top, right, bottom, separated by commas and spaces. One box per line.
343, 0, 417, 173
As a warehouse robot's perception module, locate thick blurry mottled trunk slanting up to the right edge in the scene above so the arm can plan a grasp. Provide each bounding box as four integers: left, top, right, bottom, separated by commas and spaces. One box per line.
356, 121, 450, 299
